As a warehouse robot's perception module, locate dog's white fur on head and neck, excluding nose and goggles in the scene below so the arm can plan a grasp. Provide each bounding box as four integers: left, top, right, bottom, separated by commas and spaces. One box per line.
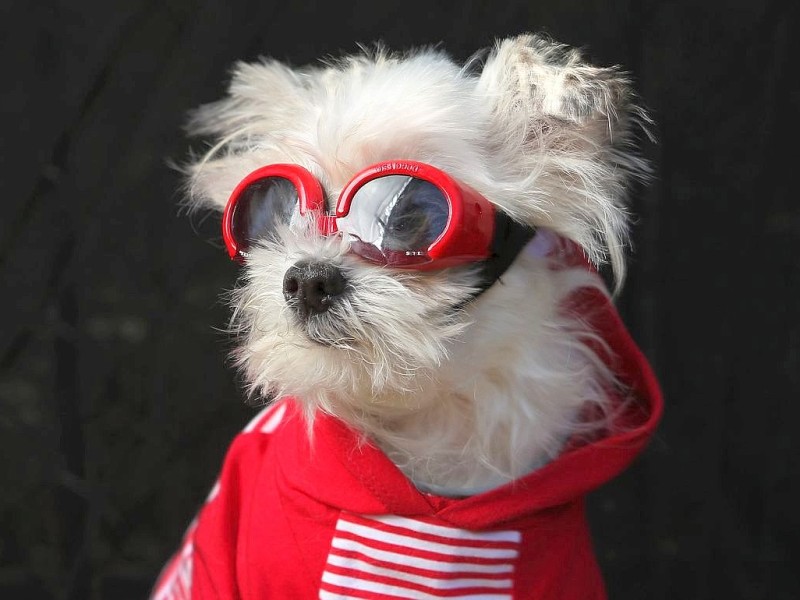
188, 36, 646, 496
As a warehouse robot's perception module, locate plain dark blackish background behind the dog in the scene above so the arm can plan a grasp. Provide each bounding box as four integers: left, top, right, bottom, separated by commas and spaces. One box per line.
0, 0, 800, 600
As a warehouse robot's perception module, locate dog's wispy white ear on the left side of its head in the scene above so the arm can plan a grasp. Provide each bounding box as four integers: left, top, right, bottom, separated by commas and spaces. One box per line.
182, 60, 308, 210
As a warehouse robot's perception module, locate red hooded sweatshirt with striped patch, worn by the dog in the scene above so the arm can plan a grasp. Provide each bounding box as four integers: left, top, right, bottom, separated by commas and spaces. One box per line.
152, 290, 662, 600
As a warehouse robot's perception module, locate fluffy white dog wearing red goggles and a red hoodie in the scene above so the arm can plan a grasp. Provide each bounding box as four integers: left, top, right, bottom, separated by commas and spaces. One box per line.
153, 34, 661, 599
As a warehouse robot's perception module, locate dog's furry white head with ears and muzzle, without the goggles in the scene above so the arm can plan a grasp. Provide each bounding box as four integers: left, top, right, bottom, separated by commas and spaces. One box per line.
184, 36, 643, 446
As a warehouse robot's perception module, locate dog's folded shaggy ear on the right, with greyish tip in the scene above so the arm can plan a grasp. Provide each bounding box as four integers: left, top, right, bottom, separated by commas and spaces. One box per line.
478, 35, 648, 280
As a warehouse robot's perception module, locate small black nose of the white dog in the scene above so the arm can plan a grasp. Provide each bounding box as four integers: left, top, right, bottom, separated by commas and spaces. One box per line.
283, 261, 347, 319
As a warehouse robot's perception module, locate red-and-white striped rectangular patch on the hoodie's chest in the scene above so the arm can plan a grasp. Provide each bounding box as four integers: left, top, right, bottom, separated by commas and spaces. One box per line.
319, 513, 522, 600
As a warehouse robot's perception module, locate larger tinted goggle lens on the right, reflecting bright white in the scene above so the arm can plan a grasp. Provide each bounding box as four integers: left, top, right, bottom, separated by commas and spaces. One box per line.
338, 175, 450, 264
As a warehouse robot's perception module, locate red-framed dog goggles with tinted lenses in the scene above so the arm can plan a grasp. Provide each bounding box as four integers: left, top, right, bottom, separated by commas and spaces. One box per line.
222, 161, 496, 270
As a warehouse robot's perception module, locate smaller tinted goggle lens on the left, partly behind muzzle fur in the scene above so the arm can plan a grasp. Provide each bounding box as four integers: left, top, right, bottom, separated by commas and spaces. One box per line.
232, 177, 297, 251
